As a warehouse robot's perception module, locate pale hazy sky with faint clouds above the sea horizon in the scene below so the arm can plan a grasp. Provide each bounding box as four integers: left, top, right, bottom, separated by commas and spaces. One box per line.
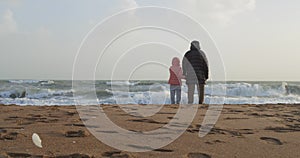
0, 0, 300, 81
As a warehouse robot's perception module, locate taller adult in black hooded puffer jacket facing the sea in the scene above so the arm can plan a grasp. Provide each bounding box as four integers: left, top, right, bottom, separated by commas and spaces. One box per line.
182, 41, 209, 104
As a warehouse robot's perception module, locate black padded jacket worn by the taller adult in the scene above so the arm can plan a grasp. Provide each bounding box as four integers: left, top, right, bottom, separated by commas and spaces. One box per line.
182, 45, 209, 84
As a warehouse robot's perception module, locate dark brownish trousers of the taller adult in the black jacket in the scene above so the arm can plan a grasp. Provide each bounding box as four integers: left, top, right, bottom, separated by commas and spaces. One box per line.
187, 84, 204, 104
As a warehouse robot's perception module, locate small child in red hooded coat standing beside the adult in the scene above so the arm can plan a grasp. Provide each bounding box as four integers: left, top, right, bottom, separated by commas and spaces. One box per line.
168, 57, 184, 104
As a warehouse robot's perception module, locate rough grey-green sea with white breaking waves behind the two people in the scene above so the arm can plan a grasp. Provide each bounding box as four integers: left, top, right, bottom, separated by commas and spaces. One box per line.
0, 80, 300, 106
